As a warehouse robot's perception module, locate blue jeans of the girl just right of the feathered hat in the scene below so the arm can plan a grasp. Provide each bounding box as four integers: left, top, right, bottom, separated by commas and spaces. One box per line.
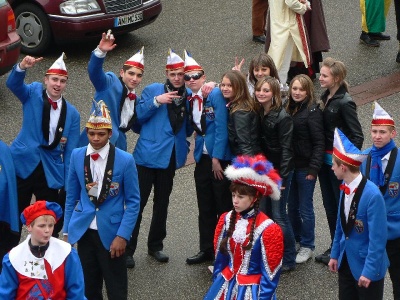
260, 172, 296, 267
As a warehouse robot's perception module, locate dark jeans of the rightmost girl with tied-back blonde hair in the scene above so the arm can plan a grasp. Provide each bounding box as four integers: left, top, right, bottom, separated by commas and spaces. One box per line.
318, 163, 342, 241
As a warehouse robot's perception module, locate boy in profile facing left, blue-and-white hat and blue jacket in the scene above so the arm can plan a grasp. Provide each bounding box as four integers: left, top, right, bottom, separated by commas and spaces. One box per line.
328, 128, 388, 300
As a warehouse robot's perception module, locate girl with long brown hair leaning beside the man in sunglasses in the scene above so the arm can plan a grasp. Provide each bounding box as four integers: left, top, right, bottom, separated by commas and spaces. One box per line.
220, 70, 261, 156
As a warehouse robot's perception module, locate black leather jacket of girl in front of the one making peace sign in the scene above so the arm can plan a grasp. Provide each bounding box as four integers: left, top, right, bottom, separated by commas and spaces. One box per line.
261, 107, 294, 180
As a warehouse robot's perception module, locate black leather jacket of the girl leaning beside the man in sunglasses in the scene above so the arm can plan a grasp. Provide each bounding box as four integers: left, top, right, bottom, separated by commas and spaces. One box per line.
228, 110, 261, 156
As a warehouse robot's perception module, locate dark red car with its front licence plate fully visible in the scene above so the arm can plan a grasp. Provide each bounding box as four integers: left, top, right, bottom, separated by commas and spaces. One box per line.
9, 0, 162, 55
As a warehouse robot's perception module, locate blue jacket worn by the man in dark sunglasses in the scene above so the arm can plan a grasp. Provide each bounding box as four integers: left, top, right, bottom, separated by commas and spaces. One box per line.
194, 88, 232, 162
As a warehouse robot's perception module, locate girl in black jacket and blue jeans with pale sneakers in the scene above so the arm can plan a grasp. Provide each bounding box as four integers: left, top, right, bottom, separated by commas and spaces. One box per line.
286, 74, 325, 263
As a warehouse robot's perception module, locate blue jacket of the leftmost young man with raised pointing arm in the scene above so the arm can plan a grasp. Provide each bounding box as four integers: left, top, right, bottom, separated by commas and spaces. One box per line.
7, 66, 80, 189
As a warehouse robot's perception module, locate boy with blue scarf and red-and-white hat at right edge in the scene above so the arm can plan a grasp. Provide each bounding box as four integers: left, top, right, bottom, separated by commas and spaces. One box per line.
361, 102, 400, 300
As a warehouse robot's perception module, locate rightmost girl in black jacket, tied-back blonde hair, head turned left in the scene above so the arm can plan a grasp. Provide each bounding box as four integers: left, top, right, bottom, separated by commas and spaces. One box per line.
315, 57, 364, 265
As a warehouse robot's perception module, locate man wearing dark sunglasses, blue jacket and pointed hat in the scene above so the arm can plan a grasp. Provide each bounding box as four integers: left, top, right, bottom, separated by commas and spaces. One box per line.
183, 51, 232, 265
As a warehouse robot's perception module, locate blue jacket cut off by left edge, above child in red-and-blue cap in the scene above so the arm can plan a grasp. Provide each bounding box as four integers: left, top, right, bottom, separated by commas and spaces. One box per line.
0, 141, 19, 232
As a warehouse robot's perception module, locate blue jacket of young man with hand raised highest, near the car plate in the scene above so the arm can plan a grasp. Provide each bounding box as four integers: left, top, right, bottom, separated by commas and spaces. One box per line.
79, 52, 140, 151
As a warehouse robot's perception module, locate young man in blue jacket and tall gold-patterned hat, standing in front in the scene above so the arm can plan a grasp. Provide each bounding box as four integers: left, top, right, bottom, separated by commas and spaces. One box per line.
63, 101, 140, 299
